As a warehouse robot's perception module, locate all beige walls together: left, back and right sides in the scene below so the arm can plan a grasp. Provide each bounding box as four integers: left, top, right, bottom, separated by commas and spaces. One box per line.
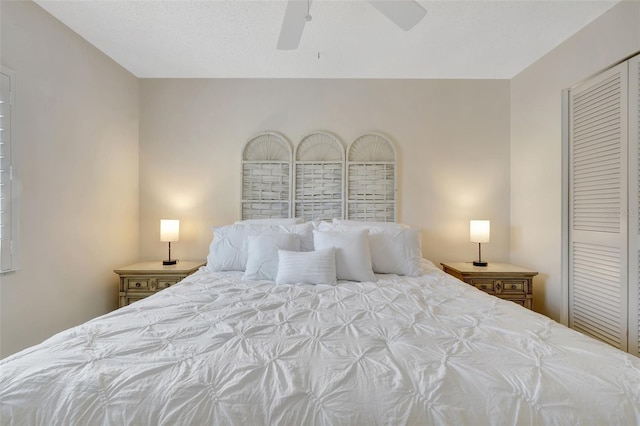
0, 1, 640, 356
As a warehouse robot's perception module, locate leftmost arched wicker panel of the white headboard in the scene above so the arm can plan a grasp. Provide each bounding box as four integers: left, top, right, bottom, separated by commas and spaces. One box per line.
240, 132, 293, 219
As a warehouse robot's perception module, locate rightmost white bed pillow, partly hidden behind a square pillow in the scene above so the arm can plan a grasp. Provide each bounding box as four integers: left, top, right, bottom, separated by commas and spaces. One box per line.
318, 223, 422, 276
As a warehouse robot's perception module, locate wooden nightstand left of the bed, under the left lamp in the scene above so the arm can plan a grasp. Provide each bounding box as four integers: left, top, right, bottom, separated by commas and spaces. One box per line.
113, 261, 206, 307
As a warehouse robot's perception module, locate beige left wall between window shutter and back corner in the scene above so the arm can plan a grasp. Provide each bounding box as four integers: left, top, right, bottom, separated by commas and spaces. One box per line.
0, 1, 138, 357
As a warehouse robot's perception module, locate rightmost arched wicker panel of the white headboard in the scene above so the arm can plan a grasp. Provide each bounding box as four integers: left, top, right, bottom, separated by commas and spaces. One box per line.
346, 133, 397, 222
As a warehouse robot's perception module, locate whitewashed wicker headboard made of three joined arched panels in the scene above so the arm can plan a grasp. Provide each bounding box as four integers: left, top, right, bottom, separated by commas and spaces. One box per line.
240, 131, 398, 222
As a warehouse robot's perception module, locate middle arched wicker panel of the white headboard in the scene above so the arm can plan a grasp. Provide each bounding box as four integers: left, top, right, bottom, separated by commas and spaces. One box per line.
293, 131, 345, 220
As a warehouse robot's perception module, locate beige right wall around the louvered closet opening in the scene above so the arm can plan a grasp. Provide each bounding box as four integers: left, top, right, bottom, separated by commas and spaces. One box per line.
511, 1, 640, 320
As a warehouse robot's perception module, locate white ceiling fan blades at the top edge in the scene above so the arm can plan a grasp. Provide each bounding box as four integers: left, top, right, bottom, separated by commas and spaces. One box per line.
278, 0, 427, 50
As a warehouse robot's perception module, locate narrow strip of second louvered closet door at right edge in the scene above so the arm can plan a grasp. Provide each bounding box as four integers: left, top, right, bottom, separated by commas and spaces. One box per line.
628, 55, 640, 356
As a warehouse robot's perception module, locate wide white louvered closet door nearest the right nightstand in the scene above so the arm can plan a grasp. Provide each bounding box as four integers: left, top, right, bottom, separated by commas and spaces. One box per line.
569, 63, 628, 351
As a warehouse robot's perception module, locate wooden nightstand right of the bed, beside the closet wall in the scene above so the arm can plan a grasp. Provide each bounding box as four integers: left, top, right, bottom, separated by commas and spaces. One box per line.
441, 262, 538, 310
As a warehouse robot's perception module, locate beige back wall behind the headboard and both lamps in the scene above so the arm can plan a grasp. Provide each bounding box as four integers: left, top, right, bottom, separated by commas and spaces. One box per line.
140, 79, 510, 268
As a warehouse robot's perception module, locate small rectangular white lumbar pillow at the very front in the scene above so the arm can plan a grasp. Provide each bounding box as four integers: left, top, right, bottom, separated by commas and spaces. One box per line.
276, 247, 336, 284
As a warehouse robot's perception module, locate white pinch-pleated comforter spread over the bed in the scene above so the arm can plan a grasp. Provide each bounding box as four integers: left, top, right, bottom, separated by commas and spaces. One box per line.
0, 265, 640, 425
